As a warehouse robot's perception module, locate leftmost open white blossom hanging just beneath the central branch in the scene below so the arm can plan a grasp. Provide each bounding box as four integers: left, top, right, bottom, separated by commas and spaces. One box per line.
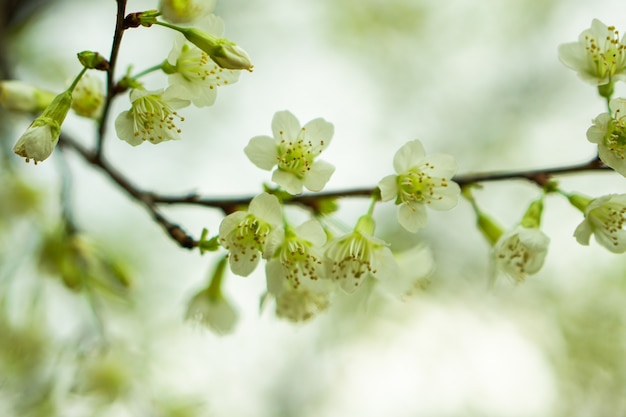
219, 193, 282, 277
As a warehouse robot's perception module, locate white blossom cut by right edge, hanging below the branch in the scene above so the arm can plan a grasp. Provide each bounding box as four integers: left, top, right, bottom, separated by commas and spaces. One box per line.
574, 194, 626, 253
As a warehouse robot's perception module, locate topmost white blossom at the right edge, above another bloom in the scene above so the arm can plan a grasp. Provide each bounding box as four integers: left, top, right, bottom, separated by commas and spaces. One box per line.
559, 19, 626, 85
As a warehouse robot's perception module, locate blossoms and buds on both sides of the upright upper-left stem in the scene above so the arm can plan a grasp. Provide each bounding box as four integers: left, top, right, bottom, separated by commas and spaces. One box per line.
6, 0, 252, 163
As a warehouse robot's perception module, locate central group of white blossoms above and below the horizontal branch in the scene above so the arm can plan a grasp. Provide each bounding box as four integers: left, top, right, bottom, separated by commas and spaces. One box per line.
212, 111, 460, 321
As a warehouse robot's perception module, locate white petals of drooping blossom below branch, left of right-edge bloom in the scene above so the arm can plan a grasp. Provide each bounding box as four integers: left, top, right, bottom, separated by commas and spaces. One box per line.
493, 225, 550, 282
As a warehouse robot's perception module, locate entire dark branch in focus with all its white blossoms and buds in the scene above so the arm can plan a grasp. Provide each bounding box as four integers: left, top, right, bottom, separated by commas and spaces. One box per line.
0, 0, 626, 333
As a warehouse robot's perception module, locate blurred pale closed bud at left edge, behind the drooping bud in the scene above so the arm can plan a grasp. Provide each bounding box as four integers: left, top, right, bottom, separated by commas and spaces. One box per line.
0, 80, 54, 113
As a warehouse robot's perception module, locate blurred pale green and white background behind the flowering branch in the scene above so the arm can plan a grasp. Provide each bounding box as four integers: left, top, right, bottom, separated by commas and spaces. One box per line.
0, 0, 626, 417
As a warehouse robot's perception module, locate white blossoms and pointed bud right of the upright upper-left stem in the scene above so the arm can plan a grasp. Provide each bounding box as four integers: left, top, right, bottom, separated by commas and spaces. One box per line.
115, 11, 252, 146
